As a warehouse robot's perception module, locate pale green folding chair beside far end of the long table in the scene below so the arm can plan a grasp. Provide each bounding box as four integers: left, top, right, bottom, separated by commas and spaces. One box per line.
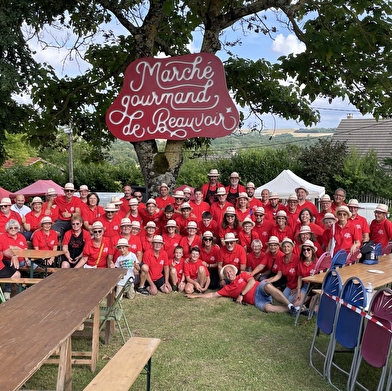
99, 277, 133, 343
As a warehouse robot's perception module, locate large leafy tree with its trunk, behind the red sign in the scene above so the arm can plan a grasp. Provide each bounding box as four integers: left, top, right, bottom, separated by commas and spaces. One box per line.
0, 0, 392, 190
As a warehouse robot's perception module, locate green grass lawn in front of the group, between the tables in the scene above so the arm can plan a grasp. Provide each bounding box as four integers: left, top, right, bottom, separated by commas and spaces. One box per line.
26, 293, 379, 391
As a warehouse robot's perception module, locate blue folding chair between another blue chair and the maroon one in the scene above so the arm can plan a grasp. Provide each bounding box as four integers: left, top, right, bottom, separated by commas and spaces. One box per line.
326, 277, 367, 390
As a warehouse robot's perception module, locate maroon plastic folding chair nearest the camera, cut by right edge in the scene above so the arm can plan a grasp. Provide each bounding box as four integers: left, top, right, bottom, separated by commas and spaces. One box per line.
350, 288, 392, 391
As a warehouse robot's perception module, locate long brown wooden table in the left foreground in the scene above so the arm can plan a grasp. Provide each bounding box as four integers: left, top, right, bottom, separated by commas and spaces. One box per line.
0, 268, 124, 391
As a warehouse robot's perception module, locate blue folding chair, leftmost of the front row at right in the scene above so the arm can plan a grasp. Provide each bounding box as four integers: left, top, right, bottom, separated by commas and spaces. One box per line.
309, 270, 342, 377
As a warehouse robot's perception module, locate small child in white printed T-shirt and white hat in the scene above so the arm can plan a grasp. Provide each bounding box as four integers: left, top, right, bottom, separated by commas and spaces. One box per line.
114, 238, 139, 299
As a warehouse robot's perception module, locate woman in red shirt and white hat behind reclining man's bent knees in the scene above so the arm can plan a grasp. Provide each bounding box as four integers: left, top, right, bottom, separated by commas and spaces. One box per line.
267, 238, 299, 303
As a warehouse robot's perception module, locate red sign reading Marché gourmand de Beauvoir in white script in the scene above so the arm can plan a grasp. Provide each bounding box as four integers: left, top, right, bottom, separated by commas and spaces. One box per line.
106, 53, 239, 142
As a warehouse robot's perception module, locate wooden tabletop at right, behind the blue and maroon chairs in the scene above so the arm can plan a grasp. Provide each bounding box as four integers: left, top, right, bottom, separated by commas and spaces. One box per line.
302, 254, 392, 288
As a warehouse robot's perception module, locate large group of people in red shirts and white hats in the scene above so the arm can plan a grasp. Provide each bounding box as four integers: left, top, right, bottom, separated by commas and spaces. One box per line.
0, 169, 392, 314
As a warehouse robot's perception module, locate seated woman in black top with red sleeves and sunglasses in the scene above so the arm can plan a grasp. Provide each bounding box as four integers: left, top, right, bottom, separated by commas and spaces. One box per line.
61, 215, 91, 269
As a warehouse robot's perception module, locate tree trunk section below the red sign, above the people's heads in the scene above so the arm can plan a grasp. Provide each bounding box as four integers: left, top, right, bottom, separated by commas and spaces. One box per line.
133, 140, 184, 197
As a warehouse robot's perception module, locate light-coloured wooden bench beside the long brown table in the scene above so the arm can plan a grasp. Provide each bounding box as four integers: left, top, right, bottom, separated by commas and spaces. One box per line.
84, 337, 161, 391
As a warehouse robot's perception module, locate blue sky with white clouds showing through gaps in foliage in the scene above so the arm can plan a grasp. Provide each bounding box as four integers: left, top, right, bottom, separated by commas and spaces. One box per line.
19, 8, 371, 130
